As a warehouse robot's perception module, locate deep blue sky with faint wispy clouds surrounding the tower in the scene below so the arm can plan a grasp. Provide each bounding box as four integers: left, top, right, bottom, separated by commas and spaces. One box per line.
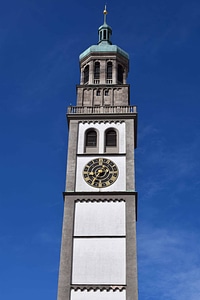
0, 0, 200, 300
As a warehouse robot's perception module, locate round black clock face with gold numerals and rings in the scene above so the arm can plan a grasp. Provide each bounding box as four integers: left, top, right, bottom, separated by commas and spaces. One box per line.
83, 157, 119, 188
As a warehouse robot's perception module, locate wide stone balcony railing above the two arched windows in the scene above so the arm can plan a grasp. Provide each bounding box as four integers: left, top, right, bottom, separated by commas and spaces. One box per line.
67, 105, 137, 114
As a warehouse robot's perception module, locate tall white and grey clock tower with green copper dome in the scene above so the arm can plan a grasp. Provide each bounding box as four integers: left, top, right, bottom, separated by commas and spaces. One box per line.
58, 8, 138, 300
